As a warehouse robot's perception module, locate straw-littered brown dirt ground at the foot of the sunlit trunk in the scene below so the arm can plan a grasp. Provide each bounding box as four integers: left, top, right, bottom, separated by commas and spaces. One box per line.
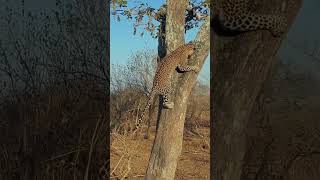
110, 116, 210, 180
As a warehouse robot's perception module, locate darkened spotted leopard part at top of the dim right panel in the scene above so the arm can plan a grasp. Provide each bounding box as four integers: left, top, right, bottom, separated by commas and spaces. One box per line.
210, 0, 287, 37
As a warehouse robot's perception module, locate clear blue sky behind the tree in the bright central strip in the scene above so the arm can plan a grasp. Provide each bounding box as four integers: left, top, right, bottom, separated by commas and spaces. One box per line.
110, 0, 210, 83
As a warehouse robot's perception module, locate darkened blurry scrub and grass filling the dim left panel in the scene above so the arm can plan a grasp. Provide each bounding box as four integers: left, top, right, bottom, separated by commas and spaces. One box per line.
0, 0, 109, 180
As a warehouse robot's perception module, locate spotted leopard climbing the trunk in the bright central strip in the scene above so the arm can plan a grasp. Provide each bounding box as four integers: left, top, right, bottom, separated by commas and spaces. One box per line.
134, 42, 200, 137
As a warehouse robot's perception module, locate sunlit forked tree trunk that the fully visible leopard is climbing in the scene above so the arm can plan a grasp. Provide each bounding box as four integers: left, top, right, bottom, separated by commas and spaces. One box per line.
145, 0, 210, 180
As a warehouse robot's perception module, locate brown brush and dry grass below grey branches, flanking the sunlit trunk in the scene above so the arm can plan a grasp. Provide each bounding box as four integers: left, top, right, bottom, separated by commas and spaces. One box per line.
110, 80, 210, 180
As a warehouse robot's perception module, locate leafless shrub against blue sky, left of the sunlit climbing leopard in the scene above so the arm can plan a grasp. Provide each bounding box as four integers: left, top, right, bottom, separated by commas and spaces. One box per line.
110, 49, 156, 134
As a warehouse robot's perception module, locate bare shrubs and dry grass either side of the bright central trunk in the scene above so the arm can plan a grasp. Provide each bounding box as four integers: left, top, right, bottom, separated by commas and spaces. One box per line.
110, 49, 210, 179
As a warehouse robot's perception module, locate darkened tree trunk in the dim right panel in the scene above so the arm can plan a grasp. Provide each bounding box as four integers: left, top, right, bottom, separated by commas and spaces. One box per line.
211, 0, 302, 180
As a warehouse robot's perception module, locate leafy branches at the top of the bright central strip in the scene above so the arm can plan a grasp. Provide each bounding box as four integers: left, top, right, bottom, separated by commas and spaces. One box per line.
111, 0, 210, 38
